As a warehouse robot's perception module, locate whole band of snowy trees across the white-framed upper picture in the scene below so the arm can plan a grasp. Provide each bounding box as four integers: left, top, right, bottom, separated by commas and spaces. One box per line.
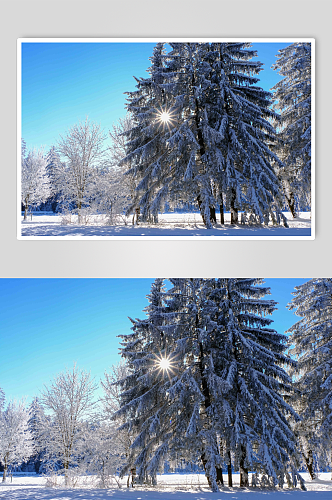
22, 42, 311, 228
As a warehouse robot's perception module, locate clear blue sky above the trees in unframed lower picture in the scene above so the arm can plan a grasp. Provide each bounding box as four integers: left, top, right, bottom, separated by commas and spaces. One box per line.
0, 278, 306, 402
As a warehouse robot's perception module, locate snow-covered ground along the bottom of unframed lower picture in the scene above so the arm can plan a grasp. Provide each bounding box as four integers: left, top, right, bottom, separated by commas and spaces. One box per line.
0, 472, 332, 500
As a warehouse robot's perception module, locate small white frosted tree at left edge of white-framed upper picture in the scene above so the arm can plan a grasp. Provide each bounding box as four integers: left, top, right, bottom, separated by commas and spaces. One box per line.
21, 141, 51, 220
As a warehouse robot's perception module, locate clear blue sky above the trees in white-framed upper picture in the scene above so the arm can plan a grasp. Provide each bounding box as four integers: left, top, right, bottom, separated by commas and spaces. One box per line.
22, 42, 288, 150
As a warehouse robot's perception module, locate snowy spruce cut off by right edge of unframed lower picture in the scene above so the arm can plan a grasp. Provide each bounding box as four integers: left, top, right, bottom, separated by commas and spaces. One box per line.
289, 278, 332, 478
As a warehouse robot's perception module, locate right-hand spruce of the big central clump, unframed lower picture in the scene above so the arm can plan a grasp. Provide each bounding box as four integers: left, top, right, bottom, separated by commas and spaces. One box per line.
202, 278, 303, 487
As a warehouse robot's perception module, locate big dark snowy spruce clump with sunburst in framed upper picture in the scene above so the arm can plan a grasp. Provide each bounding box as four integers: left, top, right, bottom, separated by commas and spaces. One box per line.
122, 43, 286, 228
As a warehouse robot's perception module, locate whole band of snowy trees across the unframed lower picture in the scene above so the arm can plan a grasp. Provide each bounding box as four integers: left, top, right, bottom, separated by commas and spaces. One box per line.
0, 278, 332, 491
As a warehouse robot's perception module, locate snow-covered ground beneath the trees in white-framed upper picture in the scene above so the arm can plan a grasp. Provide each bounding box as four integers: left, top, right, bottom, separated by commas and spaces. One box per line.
21, 212, 311, 239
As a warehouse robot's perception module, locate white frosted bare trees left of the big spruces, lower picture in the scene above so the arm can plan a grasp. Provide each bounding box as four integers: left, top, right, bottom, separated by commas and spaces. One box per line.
0, 363, 127, 488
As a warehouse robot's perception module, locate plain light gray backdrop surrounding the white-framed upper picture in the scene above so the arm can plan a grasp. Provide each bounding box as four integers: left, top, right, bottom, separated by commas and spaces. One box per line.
0, 0, 332, 277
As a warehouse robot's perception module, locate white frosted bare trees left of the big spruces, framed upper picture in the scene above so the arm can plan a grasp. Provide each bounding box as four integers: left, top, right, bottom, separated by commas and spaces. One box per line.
21, 116, 132, 224
